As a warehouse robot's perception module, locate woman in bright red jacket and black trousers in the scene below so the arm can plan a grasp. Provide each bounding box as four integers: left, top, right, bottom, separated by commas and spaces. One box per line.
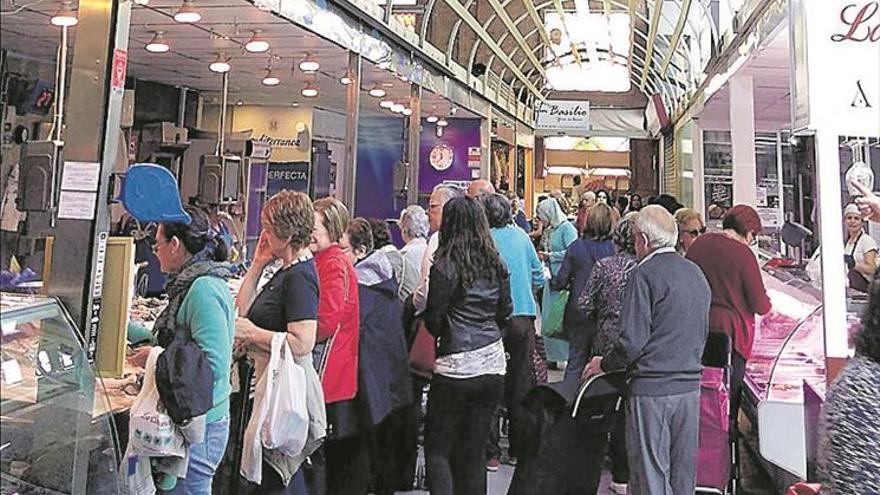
309, 198, 369, 494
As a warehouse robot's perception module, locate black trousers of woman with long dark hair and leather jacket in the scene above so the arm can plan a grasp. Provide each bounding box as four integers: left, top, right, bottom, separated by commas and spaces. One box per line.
425, 375, 504, 495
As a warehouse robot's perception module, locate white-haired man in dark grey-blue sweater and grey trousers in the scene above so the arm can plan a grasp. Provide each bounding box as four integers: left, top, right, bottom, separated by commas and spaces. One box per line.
584, 205, 711, 495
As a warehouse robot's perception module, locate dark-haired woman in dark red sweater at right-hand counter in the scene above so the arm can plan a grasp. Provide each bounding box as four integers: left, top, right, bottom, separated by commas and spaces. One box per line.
687, 205, 770, 430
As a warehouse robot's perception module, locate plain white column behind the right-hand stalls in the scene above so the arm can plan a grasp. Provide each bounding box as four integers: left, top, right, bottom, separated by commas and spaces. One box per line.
730, 76, 758, 206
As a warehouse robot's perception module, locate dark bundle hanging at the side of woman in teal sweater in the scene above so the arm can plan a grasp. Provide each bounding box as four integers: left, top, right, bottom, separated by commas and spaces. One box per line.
156, 327, 214, 424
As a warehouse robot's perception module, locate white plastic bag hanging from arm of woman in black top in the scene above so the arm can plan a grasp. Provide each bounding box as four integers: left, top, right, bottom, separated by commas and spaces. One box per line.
260, 333, 309, 456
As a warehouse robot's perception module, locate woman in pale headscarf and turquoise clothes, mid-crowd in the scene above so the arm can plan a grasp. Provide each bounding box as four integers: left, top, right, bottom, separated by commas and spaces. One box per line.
537, 198, 578, 362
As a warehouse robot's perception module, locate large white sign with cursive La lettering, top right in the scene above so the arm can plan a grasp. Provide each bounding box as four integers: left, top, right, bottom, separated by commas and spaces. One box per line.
791, 0, 880, 136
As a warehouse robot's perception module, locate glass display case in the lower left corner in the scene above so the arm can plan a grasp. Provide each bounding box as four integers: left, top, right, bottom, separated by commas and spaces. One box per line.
0, 294, 122, 495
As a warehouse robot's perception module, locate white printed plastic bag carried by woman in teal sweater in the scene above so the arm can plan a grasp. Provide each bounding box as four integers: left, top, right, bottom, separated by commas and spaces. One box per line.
128, 346, 186, 457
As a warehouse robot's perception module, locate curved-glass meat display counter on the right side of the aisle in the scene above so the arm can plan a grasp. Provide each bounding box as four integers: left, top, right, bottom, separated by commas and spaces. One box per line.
743, 266, 860, 486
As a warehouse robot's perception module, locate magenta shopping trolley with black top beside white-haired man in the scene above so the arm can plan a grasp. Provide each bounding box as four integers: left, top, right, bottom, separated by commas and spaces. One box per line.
697, 332, 739, 495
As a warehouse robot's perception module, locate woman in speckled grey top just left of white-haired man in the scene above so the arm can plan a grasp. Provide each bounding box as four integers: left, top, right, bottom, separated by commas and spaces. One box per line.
578, 214, 637, 495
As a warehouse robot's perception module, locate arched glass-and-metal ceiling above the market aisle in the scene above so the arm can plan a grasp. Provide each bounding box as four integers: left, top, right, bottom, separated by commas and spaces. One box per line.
402, 0, 718, 110
